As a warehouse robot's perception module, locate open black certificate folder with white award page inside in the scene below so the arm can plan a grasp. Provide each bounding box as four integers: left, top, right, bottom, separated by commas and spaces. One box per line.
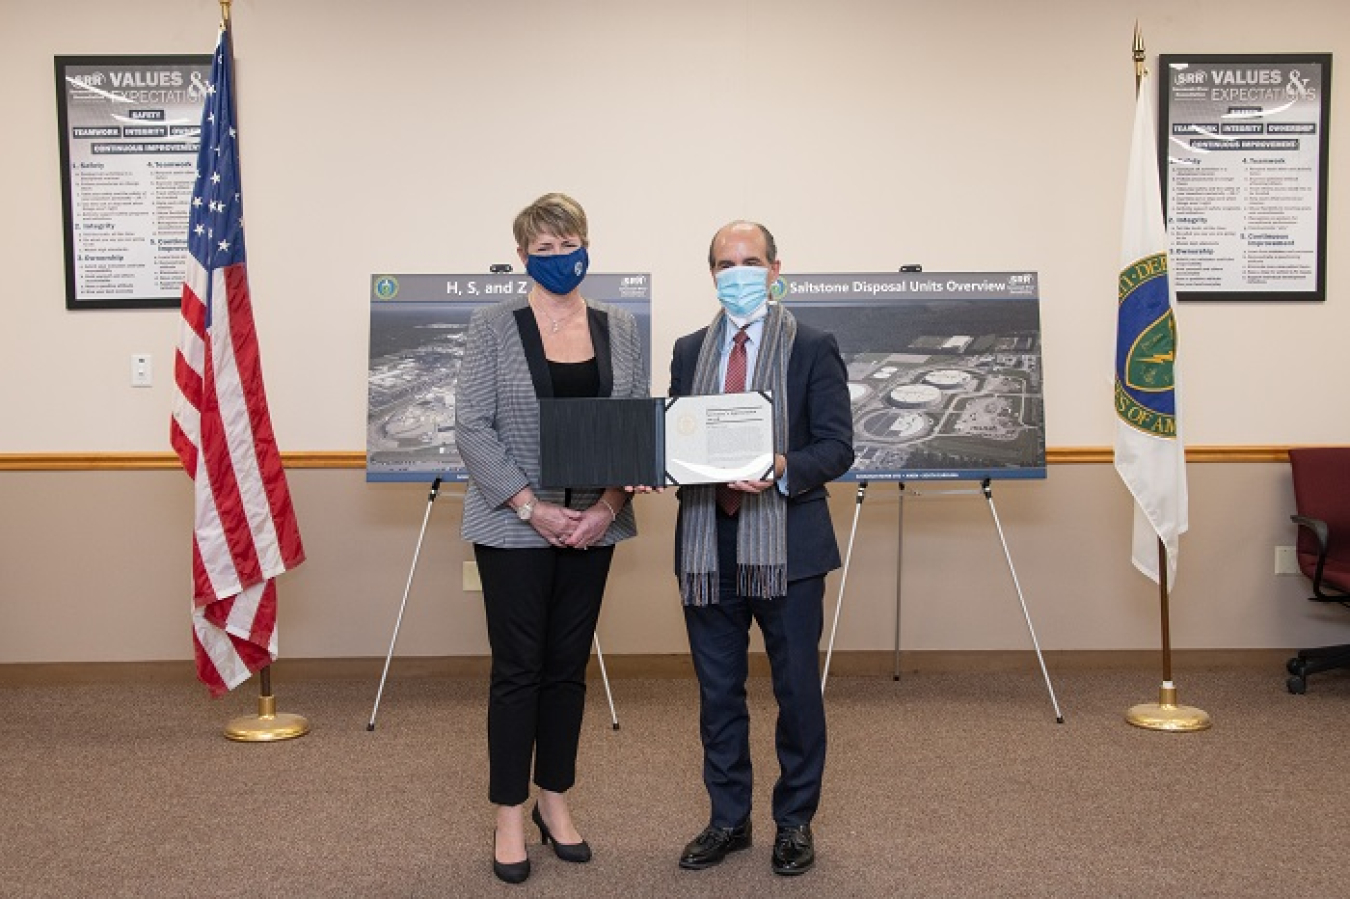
539, 391, 774, 487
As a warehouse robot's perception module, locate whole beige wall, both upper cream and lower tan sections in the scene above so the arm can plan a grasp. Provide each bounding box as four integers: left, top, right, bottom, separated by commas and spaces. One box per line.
0, 0, 1350, 663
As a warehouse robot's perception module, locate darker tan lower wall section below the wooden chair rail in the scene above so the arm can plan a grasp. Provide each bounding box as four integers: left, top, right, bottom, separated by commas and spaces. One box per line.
0, 463, 1350, 663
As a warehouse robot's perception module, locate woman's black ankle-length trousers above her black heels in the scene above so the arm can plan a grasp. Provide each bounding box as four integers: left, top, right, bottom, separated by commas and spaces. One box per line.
474, 544, 614, 806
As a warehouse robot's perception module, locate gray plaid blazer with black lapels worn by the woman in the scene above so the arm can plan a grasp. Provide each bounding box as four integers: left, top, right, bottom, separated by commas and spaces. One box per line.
455, 297, 651, 549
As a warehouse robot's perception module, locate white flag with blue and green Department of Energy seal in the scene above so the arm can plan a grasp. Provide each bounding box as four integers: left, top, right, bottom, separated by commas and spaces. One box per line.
1115, 76, 1187, 583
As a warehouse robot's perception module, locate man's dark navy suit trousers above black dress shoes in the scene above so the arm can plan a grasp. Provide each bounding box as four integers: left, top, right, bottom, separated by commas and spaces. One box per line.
684, 516, 826, 827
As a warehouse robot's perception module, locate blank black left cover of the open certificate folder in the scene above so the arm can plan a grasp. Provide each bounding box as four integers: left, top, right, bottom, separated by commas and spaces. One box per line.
539, 398, 666, 487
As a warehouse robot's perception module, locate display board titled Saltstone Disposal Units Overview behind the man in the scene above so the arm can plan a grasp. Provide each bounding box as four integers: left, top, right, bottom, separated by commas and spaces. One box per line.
774, 271, 1045, 481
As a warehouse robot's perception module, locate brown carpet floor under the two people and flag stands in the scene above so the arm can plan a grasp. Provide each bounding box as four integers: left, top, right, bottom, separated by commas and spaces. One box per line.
0, 664, 1350, 899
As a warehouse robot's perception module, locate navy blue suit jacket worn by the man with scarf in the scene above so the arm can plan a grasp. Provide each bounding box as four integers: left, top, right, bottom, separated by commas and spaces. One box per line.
670, 323, 853, 580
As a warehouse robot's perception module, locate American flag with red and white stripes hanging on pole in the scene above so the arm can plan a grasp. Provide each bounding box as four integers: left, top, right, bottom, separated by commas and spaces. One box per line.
170, 21, 305, 697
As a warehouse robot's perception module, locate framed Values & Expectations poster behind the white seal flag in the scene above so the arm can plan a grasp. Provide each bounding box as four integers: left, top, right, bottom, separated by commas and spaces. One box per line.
1158, 53, 1331, 301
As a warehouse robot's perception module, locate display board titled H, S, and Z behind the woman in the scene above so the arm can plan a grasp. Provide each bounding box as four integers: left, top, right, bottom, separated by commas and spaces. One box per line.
366, 273, 652, 482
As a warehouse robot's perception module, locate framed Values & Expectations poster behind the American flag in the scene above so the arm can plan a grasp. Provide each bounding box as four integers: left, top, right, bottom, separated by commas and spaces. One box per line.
55, 54, 211, 309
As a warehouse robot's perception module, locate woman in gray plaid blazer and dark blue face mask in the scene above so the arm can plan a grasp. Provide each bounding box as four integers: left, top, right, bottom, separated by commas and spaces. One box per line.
455, 193, 649, 883
